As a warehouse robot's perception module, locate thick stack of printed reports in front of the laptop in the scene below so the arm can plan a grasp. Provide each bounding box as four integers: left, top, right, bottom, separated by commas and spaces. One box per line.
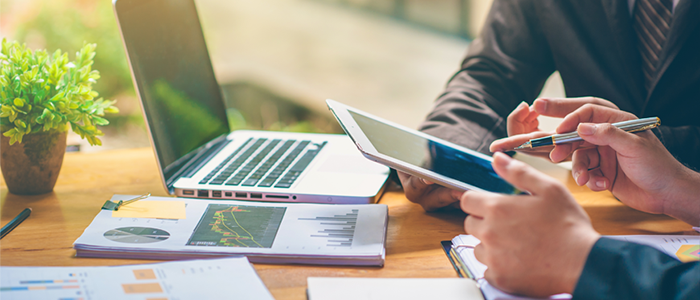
73, 195, 388, 266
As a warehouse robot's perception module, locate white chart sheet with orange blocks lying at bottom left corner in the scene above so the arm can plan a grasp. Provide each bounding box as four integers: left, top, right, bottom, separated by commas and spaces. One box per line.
0, 257, 273, 300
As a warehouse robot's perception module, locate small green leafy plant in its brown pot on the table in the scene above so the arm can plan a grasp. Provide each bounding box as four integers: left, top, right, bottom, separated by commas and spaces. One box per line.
0, 39, 119, 195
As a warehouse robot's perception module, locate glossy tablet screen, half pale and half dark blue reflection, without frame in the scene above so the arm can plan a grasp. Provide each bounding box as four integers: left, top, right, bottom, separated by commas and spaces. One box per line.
349, 111, 517, 194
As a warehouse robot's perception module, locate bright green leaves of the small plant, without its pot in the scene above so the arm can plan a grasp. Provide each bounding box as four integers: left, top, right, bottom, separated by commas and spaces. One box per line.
0, 39, 119, 145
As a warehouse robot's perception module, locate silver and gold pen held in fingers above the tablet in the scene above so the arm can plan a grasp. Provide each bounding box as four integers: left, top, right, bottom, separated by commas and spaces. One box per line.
513, 117, 661, 150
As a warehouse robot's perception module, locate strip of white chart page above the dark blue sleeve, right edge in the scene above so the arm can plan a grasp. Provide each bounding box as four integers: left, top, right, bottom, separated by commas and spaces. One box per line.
606, 235, 700, 262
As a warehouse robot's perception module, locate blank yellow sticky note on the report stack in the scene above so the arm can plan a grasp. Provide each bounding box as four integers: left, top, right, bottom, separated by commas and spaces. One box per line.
112, 200, 186, 219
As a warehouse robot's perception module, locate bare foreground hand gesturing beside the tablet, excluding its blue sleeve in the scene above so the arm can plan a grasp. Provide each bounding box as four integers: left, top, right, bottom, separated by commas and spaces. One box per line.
461, 153, 599, 297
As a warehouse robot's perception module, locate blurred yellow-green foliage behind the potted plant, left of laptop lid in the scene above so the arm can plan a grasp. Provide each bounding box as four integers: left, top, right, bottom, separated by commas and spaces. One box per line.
0, 0, 145, 145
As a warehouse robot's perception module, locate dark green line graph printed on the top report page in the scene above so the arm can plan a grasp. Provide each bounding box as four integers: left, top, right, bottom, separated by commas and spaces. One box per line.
187, 204, 286, 248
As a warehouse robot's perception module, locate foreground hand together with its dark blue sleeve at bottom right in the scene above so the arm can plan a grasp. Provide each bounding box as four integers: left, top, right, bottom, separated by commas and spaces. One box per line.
461, 153, 700, 299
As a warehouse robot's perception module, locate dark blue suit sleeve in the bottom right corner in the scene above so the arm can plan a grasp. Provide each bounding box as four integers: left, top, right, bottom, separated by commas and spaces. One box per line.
573, 238, 700, 300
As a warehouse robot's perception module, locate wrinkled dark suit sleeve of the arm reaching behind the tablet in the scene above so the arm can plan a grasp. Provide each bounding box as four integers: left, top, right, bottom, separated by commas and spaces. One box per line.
421, 0, 555, 154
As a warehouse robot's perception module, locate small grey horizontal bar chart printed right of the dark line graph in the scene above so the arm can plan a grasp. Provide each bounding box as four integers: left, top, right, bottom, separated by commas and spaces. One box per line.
299, 209, 359, 247
